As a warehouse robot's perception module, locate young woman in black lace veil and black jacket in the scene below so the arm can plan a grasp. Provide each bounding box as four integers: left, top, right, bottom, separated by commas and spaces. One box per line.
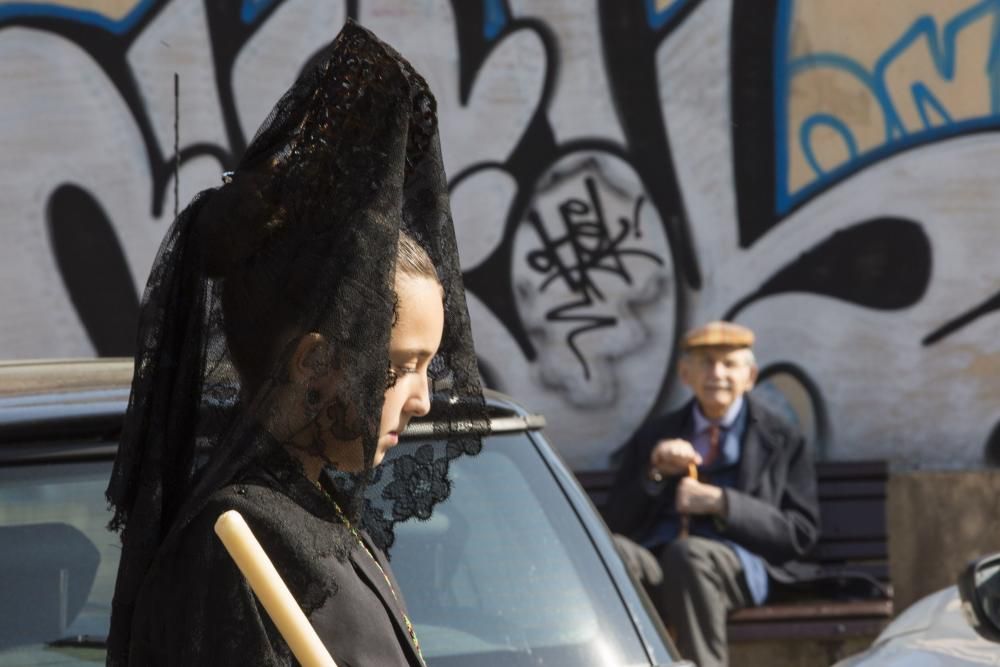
108, 23, 484, 667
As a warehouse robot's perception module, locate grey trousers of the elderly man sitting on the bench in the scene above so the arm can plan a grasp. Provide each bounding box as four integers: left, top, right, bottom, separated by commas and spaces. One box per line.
615, 535, 753, 667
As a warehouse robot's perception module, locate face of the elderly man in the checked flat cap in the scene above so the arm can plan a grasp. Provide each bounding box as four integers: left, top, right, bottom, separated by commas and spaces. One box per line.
679, 347, 757, 419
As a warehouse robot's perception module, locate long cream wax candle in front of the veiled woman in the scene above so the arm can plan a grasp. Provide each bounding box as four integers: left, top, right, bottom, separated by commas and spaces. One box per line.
215, 510, 337, 667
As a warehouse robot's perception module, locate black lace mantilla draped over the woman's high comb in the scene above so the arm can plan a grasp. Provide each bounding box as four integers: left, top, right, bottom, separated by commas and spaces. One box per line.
108, 22, 485, 664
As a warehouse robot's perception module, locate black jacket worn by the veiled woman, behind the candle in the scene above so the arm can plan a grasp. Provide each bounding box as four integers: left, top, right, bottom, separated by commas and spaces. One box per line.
129, 442, 423, 667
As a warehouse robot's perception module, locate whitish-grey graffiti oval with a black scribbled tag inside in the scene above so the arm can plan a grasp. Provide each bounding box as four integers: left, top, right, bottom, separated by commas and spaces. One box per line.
513, 153, 674, 407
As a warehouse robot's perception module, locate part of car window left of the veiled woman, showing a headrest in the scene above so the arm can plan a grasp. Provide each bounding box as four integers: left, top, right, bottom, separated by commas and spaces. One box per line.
0, 461, 119, 666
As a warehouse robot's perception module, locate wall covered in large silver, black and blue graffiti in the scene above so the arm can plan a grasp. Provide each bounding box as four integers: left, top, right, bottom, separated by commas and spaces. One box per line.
0, 0, 1000, 468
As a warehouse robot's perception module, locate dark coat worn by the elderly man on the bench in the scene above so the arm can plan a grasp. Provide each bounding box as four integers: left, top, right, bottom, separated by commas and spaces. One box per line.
605, 396, 819, 583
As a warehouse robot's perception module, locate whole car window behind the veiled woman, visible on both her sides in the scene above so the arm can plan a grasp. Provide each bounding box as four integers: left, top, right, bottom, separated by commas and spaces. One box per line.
0, 433, 649, 667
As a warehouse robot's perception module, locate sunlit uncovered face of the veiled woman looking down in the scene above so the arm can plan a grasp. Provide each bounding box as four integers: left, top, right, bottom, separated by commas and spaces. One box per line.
373, 275, 444, 465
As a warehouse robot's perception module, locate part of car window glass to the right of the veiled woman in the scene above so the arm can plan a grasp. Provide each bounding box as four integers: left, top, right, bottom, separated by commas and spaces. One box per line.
391, 433, 649, 667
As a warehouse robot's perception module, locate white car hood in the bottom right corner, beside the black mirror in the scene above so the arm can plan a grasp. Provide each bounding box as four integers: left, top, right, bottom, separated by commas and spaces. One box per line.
834, 586, 1000, 667
